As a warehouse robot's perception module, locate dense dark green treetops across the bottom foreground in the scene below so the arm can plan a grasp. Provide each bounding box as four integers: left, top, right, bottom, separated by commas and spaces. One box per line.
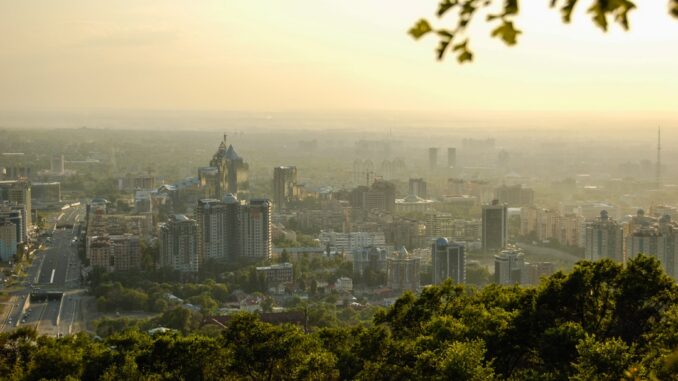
0, 255, 678, 381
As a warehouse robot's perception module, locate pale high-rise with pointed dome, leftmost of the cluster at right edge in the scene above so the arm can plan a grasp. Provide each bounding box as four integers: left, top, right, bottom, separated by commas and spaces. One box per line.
585, 210, 624, 262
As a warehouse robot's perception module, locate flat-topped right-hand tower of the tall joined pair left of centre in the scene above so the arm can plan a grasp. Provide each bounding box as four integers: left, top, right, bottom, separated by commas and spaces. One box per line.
240, 199, 273, 260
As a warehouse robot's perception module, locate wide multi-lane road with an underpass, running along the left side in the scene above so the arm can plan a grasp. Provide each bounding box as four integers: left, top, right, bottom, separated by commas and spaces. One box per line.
0, 208, 83, 336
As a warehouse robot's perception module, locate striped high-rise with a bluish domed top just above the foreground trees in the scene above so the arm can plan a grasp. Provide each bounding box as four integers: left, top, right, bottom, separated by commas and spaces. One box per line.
431, 238, 466, 283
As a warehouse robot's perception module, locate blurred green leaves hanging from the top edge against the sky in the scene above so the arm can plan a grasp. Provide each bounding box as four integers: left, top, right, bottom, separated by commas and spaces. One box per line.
409, 0, 678, 63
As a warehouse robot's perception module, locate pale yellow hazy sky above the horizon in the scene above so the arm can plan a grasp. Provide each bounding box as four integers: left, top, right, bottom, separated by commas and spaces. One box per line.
0, 0, 678, 118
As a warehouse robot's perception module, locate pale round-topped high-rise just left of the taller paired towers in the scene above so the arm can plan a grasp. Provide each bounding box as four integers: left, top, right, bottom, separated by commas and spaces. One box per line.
159, 214, 200, 273
